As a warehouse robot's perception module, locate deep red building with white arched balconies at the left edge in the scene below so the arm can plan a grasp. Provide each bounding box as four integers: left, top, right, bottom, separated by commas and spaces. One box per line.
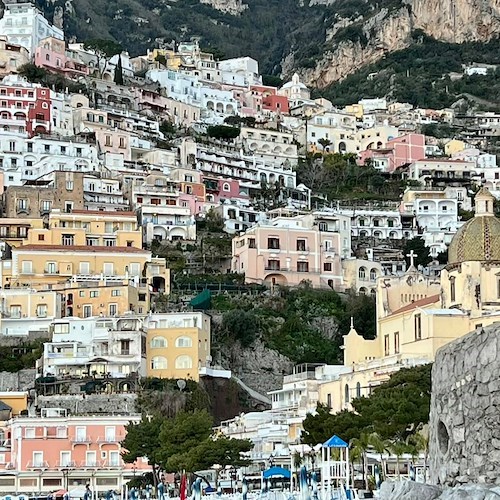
0, 84, 51, 137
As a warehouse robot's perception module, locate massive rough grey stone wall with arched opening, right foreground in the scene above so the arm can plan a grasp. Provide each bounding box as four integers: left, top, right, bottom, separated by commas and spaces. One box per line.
429, 323, 500, 486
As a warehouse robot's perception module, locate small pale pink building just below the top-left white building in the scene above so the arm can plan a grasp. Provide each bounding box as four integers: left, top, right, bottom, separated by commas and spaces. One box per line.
35, 37, 89, 78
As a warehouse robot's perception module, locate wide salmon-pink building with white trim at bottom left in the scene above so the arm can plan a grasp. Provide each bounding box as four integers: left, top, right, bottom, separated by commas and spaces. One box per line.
0, 408, 150, 498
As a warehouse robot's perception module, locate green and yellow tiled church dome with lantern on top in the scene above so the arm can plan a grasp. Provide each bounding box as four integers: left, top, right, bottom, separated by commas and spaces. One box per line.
448, 188, 500, 264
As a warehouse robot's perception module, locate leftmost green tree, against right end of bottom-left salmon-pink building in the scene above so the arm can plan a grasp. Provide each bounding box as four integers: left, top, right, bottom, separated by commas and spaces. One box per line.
122, 417, 163, 486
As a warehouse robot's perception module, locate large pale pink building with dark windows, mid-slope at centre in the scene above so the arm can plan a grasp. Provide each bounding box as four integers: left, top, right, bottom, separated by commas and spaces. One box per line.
232, 213, 351, 289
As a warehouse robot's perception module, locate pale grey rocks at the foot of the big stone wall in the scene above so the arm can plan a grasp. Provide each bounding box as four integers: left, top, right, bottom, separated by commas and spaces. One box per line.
378, 481, 500, 500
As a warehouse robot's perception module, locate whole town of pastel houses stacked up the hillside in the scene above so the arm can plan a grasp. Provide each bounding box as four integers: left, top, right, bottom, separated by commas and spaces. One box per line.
0, 0, 500, 500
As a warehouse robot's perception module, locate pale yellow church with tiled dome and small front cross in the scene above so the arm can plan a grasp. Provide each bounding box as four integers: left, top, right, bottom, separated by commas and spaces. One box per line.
319, 188, 500, 412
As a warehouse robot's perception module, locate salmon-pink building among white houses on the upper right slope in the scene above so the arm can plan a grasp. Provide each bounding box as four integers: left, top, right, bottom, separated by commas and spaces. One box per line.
359, 134, 426, 172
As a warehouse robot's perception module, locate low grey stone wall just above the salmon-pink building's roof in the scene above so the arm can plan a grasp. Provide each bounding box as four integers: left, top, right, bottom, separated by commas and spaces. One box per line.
37, 394, 138, 415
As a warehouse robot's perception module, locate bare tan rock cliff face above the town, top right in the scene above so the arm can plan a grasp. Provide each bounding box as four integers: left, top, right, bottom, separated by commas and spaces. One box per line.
294, 0, 500, 88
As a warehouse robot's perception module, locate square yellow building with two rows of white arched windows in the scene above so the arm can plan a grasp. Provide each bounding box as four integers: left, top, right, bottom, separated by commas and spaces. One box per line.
146, 313, 211, 380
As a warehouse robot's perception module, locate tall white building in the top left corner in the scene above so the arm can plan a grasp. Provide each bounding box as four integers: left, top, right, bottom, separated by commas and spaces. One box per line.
0, 0, 64, 56
